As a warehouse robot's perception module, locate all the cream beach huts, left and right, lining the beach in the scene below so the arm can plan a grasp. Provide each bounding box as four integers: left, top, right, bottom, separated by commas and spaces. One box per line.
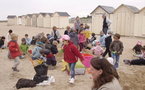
8, 4, 145, 37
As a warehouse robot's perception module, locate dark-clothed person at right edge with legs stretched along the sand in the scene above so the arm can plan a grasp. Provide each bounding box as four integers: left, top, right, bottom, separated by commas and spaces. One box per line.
123, 46, 145, 65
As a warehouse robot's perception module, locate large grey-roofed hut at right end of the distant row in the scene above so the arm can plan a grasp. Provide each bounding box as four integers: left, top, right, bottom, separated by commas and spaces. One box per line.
51, 12, 70, 28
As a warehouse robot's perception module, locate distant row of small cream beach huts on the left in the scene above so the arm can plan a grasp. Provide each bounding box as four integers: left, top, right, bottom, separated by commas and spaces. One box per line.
7, 12, 70, 28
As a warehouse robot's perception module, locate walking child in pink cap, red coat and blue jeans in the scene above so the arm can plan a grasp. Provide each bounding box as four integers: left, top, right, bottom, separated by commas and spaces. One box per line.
62, 35, 84, 84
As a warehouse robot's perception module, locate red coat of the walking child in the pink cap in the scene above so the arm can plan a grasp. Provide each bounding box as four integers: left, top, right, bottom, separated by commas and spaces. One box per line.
63, 42, 84, 63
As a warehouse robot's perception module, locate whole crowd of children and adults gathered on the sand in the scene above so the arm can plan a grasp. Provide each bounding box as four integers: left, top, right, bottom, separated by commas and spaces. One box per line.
0, 15, 145, 90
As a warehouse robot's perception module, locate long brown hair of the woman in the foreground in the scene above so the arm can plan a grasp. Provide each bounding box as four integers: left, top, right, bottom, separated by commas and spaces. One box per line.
90, 57, 119, 89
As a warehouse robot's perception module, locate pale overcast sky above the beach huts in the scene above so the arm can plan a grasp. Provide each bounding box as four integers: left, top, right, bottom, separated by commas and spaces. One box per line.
0, 0, 145, 20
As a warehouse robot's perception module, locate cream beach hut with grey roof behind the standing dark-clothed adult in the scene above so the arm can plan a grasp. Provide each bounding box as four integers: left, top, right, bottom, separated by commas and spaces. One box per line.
91, 5, 114, 34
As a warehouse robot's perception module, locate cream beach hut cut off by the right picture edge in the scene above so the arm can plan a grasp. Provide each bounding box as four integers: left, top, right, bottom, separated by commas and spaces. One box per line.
134, 7, 145, 37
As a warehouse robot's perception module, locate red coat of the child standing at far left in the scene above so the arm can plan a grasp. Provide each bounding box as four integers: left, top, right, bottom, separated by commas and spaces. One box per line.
8, 41, 21, 59
